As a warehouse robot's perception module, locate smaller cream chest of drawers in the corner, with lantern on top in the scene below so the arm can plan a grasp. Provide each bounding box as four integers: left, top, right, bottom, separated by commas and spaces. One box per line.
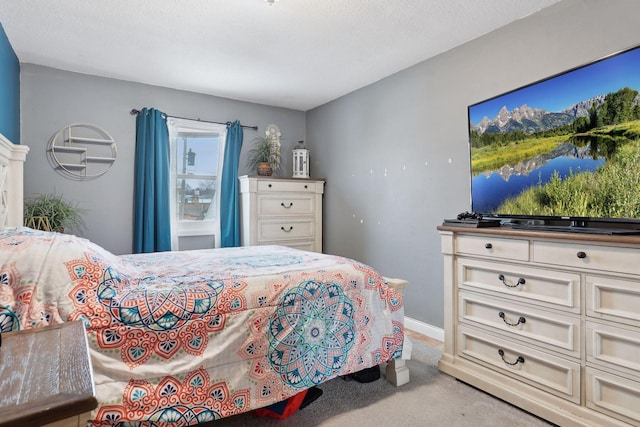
240, 175, 324, 252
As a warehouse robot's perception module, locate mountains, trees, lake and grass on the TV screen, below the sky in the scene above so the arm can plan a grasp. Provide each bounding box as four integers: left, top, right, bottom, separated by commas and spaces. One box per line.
469, 87, 640, 218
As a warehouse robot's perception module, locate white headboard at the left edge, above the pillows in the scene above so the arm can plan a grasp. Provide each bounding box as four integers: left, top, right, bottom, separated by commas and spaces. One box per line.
0, 134, 29, 227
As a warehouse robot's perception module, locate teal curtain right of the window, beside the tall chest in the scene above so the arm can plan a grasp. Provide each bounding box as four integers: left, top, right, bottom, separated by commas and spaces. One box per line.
220, 120, 243, 248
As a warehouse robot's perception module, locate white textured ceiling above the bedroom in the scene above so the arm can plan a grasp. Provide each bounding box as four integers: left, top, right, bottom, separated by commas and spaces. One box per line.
0, 0, 559, 111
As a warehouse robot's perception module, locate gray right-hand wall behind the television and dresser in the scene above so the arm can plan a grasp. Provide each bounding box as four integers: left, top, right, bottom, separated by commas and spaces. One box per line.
307, 0, 640, 327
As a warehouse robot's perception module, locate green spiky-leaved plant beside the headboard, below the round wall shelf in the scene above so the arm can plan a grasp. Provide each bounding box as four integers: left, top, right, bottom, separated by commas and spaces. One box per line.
24, 194, 84, 233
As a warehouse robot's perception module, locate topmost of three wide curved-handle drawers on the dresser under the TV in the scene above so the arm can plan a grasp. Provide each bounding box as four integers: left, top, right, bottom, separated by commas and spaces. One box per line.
458, 257, 580, 313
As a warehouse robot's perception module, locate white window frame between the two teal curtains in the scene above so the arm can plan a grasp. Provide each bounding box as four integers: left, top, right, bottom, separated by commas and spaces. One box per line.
167, 117, 227, 251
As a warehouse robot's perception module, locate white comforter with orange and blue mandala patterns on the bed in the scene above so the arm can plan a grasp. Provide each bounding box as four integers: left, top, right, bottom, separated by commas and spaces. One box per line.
0, 228, 404, 427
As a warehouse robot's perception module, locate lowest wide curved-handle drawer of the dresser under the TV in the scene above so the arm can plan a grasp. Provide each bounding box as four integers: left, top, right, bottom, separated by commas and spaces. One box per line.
457, 326, 580, 404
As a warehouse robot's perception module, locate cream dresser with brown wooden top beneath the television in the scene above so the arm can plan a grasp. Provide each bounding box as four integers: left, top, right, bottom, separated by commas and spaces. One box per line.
438, 226, 640, 426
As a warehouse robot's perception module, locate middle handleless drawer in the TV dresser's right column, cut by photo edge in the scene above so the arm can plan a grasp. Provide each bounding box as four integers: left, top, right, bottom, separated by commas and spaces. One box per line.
586, 321, 640, 378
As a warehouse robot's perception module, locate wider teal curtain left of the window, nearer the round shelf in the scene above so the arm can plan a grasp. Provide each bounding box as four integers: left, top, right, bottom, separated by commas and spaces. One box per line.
133, 108, 171, 253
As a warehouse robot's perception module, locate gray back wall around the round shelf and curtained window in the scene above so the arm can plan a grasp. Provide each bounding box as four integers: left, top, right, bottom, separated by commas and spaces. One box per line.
20, 64, 305, 254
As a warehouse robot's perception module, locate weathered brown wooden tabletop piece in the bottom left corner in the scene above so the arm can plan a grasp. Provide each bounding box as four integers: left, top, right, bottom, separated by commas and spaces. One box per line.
0, 322, 98, 427
